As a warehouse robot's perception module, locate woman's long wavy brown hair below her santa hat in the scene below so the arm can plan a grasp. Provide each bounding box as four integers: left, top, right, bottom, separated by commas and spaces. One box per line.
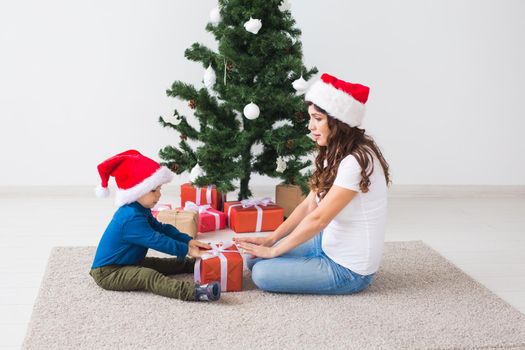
307, 102, 390, 199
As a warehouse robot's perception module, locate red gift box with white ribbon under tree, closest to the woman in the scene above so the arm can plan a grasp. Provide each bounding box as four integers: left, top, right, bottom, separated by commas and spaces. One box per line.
224, 198, 284, 233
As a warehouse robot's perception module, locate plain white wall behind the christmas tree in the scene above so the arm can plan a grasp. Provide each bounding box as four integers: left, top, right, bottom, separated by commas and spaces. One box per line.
0, 0, 525, 185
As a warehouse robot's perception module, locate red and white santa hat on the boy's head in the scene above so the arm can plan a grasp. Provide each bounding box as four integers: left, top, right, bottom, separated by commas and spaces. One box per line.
96, 150, 173, 207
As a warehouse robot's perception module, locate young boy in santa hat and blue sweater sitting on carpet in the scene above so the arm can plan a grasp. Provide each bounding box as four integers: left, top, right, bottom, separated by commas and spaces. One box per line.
89, 150, 221, 301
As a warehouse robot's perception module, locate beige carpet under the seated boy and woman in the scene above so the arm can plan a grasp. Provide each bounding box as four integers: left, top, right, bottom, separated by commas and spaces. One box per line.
23, 242, 525, 349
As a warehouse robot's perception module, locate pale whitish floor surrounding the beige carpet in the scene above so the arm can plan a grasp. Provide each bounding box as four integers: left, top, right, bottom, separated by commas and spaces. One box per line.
0, 186, 525, 349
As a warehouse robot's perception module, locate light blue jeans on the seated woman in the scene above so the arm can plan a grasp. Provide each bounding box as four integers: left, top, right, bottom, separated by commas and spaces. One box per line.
247, 232, 375, 294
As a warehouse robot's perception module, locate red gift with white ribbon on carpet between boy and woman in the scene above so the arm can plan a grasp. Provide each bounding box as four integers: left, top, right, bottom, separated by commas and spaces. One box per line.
194, 241, 243, 292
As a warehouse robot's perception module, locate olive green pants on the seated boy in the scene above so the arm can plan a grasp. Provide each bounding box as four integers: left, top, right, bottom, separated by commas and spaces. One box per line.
89, 257, 195, 300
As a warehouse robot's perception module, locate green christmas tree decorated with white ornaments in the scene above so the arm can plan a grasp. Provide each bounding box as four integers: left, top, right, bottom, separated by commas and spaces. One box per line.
159, 0, 317, 199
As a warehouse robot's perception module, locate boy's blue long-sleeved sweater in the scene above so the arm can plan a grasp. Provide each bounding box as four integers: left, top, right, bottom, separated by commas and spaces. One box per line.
91, 202, 192, 269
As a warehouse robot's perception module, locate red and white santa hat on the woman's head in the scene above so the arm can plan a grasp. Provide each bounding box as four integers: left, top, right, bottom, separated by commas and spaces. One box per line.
305, 73, 370, 127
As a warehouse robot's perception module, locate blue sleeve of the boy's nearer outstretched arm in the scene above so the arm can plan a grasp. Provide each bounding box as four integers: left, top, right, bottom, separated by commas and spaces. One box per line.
122, 215, 191, 260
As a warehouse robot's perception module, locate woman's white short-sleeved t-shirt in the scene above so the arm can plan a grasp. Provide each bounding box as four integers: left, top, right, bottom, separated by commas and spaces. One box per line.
322, 155, 387, 275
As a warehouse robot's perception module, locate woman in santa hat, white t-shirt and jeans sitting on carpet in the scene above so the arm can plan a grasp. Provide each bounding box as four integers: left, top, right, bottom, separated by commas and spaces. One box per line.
235, 74, 390, 294
